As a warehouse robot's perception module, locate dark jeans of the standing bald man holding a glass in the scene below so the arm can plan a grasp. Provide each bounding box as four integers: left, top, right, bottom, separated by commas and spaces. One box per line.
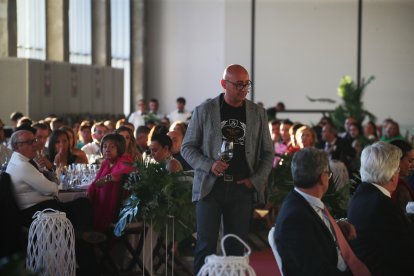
194, 178, 253, 275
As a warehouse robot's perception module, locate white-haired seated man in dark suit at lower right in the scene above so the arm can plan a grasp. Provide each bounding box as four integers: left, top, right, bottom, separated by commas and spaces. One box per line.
348, 142, 414, 275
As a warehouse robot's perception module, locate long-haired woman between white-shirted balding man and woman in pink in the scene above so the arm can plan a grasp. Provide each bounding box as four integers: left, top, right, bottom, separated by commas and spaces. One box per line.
48, 129, 88, 167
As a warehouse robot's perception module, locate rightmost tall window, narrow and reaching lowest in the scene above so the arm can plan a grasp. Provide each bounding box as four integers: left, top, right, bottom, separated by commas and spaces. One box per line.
111, 0, 131, 114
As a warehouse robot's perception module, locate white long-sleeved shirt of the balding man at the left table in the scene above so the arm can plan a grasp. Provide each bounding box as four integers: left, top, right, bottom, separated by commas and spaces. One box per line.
6, 152, 58, 209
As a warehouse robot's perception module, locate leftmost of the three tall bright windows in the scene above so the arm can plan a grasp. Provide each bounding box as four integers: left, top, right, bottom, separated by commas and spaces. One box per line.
17, 0, 46, 60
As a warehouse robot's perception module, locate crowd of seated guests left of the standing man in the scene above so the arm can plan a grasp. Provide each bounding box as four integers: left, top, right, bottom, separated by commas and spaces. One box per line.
0, 98, 196, 275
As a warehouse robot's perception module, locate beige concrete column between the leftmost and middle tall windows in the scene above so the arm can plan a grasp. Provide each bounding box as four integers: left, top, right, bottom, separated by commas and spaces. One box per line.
46, 0, 69, 62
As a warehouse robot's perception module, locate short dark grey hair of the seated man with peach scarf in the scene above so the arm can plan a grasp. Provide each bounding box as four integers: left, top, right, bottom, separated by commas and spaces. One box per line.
291, 148, 329, 188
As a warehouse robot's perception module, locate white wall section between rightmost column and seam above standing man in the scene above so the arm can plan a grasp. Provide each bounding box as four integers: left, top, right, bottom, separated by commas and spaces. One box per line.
145, 0, 225, 113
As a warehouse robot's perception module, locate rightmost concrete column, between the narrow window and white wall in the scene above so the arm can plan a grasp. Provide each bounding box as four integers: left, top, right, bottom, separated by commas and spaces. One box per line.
131, 0, 145, 111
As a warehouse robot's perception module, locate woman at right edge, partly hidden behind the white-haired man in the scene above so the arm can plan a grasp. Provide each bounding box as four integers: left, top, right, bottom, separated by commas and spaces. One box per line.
390, 140, 414, 213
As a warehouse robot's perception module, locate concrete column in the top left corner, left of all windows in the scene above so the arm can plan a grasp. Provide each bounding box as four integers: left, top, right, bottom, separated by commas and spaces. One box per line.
0, 0, 17, 57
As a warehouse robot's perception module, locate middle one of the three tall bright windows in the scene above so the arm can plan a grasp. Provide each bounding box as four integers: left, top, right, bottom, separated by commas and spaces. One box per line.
69, 0, 92, 64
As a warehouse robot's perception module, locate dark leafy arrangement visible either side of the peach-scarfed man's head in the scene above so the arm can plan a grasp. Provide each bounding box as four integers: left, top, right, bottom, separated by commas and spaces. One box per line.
268, 154, 351, 218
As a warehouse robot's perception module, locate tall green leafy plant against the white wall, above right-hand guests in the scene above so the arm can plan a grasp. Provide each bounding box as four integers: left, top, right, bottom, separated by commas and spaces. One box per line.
307, 76, 376, 129
